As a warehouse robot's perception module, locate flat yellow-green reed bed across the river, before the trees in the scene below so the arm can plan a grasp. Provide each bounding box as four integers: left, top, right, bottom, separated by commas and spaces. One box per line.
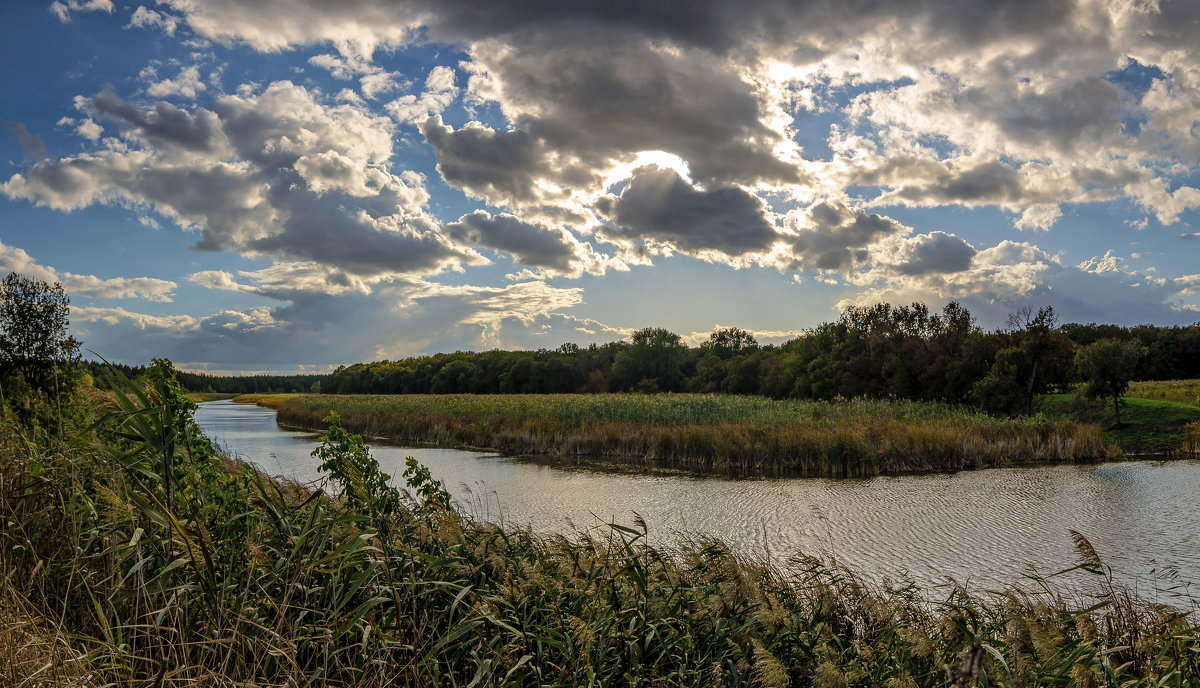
236, 394, 1115, 477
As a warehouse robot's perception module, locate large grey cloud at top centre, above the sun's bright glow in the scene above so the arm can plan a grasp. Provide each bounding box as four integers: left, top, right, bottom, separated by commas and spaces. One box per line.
468, 30, 803, 184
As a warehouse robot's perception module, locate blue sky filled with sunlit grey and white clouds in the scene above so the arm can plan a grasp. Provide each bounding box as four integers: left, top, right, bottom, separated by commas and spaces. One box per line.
0, 0, 1200, 373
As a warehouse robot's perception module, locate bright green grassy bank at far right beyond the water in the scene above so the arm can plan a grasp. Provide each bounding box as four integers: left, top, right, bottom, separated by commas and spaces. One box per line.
1038, 394, 1200, 454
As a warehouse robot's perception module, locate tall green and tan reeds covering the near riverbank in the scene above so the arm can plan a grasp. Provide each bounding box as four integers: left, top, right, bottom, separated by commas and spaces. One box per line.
0, 387, 1200, 688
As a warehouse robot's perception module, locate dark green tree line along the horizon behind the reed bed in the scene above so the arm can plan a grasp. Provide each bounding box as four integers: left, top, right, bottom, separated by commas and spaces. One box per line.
96, 303, 1200, 413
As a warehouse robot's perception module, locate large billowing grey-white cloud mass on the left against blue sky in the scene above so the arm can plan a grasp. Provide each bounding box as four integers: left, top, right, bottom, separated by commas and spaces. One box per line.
2, 82, 485, 275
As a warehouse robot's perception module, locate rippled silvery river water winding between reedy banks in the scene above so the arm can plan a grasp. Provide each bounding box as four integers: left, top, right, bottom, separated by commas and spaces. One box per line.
196, 401, 1200, 596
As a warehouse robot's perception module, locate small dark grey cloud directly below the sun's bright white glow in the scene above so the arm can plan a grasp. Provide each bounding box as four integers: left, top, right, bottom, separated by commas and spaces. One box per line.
596, 167, 781, 256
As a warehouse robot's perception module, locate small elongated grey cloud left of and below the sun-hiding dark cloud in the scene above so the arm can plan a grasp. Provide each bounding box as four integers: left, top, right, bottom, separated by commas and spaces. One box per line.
446, 210, 576, 273
